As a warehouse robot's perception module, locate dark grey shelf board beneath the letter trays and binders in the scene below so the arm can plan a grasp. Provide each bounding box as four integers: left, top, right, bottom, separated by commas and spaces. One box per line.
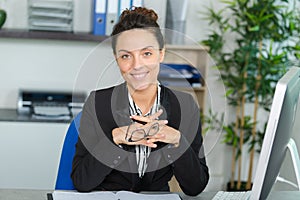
0, 29, 108, 42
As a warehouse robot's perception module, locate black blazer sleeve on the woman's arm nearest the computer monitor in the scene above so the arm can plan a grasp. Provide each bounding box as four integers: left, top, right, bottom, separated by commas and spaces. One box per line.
164, 93, 209, 196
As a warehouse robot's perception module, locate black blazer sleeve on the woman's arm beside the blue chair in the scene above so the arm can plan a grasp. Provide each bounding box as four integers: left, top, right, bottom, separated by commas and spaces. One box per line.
71, 92, 125, 192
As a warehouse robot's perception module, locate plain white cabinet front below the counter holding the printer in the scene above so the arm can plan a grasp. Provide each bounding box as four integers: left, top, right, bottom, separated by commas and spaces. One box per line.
0, 122, 68, 189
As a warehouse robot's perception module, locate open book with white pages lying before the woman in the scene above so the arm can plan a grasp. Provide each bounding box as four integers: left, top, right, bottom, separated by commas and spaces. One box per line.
48, 190, 181, 200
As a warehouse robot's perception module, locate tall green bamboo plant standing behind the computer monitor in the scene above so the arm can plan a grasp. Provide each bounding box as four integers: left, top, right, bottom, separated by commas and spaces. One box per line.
202, 0, 300, 190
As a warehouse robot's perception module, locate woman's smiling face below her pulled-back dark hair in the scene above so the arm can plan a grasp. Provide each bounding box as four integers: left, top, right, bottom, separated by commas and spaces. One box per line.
115, 29, 164, 91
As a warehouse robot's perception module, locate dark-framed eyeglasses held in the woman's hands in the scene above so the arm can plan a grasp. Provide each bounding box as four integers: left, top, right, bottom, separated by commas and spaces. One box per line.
125, 122, 159, 142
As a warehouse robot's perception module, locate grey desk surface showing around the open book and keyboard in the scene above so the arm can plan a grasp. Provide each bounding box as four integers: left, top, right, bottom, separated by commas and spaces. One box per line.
0, 189, 300, 200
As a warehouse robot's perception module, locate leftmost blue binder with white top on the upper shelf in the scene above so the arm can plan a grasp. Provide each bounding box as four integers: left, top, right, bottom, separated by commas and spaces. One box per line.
93, 0, 107, 35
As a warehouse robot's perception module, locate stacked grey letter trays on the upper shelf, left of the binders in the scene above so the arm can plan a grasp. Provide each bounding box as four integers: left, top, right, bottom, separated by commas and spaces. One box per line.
28, 0, 73, 32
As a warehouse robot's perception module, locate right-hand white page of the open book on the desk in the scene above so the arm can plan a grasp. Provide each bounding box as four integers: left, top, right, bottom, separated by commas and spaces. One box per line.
117, 191, 181, 200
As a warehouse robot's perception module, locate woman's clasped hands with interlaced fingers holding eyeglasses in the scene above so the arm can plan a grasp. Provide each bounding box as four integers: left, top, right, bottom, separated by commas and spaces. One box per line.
112, 109, 181, 148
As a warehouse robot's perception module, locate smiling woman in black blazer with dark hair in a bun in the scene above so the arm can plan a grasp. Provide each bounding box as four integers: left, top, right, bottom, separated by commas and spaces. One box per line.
71, 7, 209, 196
